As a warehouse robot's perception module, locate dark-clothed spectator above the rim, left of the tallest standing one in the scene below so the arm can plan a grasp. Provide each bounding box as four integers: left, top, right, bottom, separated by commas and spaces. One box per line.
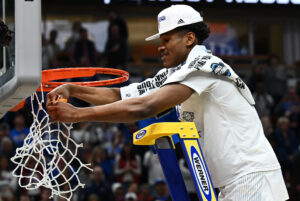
71, 28, 97, 67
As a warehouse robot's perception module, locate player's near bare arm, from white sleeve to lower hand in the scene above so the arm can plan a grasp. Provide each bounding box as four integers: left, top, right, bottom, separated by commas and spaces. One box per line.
47, 83, 194, 123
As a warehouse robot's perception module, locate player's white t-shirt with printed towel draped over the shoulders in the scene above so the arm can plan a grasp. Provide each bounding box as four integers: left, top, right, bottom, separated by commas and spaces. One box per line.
121, 46, 280, 187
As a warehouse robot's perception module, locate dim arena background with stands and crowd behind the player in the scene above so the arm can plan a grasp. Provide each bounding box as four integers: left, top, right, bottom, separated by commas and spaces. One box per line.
0, 0, 300, 201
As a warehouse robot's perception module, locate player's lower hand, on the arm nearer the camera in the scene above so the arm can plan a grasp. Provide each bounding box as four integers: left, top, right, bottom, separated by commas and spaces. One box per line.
47, 101, 79, 123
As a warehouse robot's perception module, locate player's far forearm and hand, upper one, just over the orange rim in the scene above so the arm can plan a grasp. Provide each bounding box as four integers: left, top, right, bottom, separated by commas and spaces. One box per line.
47, 84, 121, 105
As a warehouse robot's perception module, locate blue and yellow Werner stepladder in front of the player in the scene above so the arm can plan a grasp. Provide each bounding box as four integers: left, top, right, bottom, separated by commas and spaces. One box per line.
133, 122, 217, 201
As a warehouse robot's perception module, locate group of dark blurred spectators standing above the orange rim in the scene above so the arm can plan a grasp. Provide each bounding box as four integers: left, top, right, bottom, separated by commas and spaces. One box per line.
42, 11, 129, 70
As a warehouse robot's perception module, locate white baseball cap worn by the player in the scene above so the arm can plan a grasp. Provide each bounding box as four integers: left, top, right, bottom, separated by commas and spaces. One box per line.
146, 5, 203, 41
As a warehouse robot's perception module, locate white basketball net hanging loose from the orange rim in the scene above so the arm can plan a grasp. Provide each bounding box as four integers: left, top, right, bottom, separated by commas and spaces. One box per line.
11, 90, 92, 200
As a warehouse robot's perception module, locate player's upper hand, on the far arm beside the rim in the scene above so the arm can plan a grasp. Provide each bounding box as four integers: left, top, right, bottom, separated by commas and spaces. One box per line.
47, 84, 71, 106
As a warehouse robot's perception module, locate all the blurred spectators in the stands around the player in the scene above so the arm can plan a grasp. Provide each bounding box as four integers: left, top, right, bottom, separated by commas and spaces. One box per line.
0, 11, 300, 201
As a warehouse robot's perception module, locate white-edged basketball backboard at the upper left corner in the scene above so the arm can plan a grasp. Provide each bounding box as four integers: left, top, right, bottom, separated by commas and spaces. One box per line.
0, 0, 42, 118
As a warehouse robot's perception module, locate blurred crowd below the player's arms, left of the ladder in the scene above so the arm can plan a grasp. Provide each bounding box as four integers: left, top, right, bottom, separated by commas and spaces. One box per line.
0, 108, 170, 201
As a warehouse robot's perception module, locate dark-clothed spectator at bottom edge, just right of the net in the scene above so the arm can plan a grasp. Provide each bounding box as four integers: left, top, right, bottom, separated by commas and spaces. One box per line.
79, 166, 113, 201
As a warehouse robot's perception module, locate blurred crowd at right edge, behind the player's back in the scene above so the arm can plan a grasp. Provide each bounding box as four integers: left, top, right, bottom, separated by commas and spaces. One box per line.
248, 55, 300, 201
